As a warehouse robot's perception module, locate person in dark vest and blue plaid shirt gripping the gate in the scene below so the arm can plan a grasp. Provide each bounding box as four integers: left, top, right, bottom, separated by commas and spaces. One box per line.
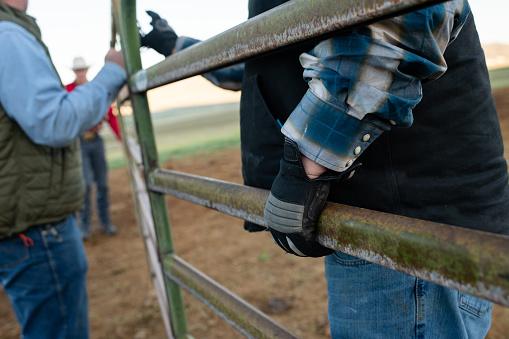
141, 0, 509, 338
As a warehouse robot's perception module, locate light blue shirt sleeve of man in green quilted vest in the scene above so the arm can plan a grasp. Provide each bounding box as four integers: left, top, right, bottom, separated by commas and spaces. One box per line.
0, 21, 127, 147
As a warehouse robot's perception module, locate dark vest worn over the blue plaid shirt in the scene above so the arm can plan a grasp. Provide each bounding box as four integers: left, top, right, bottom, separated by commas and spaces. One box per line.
241, 0, 509, 234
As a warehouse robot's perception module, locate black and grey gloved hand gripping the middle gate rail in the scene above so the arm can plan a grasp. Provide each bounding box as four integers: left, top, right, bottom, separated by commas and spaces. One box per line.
264, 138, 360, 257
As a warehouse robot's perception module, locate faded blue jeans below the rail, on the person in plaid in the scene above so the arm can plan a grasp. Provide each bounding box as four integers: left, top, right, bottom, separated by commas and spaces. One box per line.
325, 252, 493, 339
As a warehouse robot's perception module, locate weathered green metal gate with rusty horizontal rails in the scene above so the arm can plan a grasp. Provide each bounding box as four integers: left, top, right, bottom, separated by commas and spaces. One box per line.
111, 0, 509, 338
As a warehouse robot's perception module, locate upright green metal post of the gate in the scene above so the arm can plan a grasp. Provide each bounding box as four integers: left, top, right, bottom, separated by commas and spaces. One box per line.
112, 0, 189, 338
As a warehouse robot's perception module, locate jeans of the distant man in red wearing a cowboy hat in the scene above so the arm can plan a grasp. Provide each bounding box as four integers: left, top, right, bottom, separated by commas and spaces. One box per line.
80, 134, 110, 232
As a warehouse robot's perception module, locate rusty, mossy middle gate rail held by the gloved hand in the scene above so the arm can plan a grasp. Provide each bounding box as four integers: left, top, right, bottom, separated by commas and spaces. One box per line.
148, 169, 509, 306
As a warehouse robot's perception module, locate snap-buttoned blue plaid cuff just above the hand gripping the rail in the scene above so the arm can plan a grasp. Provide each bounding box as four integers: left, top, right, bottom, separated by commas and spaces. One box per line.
281, 90, 391, 172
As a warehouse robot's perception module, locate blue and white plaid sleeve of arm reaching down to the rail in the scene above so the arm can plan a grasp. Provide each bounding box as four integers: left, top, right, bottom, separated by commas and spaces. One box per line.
282, 0, 470, 172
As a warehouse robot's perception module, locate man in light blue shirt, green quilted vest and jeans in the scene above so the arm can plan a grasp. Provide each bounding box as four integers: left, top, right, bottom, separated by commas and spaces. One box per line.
0, 0, 126, 339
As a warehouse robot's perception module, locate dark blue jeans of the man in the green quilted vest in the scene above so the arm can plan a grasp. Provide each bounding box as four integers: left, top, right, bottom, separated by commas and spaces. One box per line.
0, 216, 89, 339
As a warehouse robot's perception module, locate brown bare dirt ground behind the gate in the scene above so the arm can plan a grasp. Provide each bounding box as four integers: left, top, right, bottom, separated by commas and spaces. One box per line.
0, 90, 509, 339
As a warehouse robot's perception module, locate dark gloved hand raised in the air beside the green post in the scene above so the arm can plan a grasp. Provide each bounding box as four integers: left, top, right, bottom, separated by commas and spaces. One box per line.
140, 11, 178, 56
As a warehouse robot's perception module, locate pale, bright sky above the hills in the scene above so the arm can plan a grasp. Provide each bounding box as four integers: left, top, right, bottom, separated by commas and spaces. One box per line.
28, 0, 509, 99
